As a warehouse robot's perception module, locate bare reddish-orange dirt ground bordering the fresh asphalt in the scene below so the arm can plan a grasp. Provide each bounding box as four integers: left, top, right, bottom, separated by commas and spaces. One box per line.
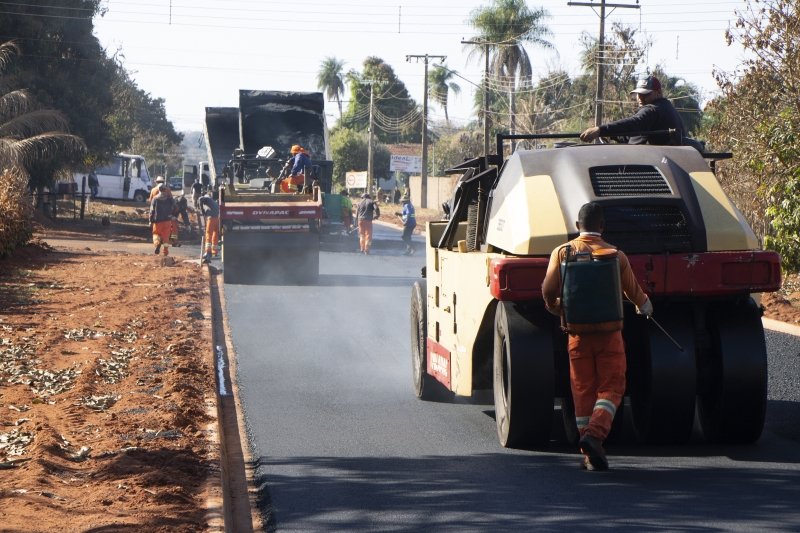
0, 197, 800, 532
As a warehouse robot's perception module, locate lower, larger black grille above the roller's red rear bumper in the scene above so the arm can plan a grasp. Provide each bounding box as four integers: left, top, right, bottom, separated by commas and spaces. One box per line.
603, 205, 693, 254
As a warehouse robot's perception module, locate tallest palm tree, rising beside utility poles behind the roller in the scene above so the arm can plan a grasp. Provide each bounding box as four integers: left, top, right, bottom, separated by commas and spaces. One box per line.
469, 0, 553, 139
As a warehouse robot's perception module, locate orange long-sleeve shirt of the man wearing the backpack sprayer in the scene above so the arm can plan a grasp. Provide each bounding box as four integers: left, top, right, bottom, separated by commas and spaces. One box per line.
542, 232, 647, 329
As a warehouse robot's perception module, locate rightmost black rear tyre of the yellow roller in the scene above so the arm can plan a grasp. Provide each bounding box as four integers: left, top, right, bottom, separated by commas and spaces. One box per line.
698, 305, 767, 444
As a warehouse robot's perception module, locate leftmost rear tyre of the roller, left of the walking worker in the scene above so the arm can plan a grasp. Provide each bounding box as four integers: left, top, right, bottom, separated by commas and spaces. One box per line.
494, 302, 555, 448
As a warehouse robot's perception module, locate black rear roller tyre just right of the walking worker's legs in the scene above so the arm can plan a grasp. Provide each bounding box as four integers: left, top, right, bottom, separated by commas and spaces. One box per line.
625, 309, 697, 444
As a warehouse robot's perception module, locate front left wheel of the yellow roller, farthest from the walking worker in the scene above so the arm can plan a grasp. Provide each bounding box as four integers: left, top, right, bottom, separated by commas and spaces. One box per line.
411, 281, 449, 401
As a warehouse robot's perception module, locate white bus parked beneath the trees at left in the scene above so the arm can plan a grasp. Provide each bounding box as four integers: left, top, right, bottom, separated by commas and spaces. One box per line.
73, 154, 153, 202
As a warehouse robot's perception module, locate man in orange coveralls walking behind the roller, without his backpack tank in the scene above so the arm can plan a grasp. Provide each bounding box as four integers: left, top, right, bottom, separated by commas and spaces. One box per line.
542, 202, 653, 470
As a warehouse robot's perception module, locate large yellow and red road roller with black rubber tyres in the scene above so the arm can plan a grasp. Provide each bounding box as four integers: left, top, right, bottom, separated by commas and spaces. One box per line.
410, 134, 781, 448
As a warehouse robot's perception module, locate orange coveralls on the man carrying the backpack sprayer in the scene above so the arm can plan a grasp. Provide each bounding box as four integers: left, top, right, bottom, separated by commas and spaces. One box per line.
542, 232, 647, 442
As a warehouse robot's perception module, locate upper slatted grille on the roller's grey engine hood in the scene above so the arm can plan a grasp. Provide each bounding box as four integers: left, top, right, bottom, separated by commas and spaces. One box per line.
589, 165, 672, 197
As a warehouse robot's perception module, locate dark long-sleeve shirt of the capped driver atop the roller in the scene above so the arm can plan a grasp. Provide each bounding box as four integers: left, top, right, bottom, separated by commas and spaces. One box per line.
600, 98, 686, 145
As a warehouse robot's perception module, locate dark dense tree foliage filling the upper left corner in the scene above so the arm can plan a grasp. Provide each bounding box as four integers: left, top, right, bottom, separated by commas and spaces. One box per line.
0, 0, 180, 183
